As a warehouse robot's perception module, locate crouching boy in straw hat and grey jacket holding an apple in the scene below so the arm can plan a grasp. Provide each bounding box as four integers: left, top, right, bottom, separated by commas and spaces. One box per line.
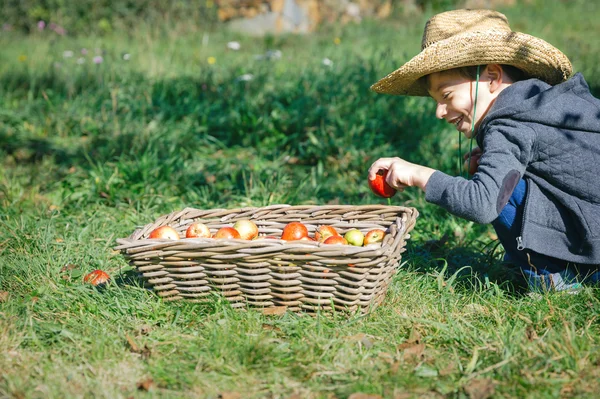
369, 10, 600, 290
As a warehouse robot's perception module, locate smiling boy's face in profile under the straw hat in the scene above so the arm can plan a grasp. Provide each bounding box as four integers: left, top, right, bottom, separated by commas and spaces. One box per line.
428, 70, 499, 138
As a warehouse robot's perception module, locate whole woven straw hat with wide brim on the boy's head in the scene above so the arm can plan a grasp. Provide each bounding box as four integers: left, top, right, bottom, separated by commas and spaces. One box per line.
371, 10, 572, 96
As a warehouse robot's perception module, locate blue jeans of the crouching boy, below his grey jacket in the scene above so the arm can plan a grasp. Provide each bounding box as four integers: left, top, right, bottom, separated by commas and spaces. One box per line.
492, 179, 600, 290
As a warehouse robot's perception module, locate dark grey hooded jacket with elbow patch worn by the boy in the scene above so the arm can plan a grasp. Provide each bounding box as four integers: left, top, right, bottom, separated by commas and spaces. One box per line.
425, 73, 600, 264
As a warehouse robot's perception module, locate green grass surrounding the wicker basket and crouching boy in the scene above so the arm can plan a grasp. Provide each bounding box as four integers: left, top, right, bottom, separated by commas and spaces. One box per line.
0, 1, 600, 398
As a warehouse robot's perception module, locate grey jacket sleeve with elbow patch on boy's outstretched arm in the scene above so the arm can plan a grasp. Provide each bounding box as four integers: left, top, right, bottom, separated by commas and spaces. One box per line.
425, 119, 535, 223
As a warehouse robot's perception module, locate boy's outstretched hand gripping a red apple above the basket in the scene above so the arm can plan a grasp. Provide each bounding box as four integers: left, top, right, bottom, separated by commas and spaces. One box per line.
369, 158, 435, 191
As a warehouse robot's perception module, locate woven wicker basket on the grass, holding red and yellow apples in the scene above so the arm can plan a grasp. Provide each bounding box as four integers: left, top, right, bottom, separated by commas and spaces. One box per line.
116, 205, 418, 313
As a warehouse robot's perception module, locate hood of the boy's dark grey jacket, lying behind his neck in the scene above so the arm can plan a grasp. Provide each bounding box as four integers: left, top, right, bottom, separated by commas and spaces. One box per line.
480, 73, 600, 132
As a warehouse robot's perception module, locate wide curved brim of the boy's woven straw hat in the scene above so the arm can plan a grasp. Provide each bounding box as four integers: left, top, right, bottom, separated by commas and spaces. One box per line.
371, 30, 572, 96
